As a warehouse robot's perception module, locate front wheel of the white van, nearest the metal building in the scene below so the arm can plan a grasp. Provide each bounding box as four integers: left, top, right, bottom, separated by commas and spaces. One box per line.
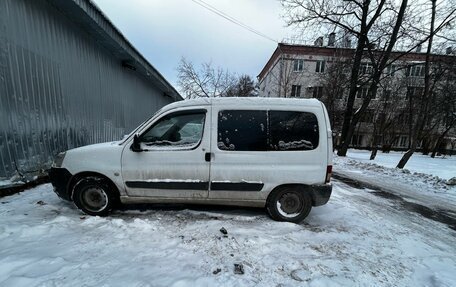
73, 176, 117, 216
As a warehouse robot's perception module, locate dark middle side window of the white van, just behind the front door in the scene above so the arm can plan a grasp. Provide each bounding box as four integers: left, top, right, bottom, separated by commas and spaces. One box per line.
217, 110, 267, 151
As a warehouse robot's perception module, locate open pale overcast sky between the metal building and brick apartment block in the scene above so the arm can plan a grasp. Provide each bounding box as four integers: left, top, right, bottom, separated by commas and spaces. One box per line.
93, 0, 291, 87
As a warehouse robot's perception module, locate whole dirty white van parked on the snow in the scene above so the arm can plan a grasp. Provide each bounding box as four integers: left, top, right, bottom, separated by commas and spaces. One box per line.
49, 98, 332, 222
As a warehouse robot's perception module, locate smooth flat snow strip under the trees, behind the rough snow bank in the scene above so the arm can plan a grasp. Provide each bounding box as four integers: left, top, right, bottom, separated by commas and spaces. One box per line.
347, 149, 456, 180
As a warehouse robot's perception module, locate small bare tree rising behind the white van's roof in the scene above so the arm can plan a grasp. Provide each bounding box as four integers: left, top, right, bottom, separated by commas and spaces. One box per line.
177, 58, 237, 98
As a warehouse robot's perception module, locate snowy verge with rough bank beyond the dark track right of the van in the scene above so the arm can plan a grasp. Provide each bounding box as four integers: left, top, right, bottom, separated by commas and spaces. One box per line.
334, 150, 456, 210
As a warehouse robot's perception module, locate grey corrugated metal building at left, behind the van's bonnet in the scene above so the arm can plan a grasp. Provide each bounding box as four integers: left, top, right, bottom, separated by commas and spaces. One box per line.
0, 0, 182, 178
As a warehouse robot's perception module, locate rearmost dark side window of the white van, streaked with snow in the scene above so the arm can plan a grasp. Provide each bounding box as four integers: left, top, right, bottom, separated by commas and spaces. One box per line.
269, 111, 319, 151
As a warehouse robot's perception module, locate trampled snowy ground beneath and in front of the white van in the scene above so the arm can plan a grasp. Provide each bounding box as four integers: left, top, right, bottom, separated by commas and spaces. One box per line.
0, 184, 456, 286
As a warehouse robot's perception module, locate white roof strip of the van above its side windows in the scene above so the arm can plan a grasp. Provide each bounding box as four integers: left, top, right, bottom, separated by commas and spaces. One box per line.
165, 97, 321, 110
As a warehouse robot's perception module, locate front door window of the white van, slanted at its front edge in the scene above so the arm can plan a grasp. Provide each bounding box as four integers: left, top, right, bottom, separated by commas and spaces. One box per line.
140, 111, 206, 149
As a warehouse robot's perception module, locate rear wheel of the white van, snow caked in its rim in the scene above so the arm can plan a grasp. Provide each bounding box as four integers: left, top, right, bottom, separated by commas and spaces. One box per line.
266, 186, 312, 223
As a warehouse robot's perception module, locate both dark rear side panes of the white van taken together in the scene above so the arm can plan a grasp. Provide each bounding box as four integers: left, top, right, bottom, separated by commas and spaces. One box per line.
217, 110, 319, 151
